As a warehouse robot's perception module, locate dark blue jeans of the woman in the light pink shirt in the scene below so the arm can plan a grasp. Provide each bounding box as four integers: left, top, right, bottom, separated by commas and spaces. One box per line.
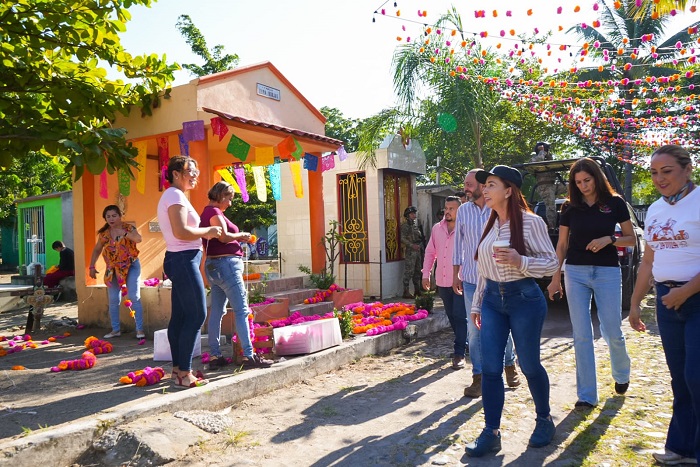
163, 250, 207, 371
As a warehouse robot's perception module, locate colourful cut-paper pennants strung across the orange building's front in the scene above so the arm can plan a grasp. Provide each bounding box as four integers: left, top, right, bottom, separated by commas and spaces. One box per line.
99, 117, 348, 203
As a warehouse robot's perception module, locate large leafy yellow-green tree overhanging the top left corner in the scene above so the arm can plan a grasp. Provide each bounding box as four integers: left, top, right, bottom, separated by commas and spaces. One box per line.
0, 0, 179, 178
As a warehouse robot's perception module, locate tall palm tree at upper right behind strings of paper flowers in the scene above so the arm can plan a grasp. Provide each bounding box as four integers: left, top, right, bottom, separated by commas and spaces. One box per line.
569, 0, 700, 199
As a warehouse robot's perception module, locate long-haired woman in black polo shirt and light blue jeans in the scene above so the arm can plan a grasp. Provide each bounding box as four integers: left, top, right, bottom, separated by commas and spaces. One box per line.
547, 157, 635, 408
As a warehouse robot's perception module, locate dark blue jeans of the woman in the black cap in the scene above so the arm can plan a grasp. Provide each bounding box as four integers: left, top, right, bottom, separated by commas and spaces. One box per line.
481, 278, 549, 430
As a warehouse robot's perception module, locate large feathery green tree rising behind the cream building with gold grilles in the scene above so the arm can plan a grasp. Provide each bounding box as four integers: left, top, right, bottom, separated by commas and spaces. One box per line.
360, 8, 572, 179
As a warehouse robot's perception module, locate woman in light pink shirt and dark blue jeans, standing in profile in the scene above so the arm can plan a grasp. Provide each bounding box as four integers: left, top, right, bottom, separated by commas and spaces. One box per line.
158, 156, 221, 389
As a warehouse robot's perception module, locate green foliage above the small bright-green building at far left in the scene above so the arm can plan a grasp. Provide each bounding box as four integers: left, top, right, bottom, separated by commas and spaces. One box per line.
0, 151, 71, 226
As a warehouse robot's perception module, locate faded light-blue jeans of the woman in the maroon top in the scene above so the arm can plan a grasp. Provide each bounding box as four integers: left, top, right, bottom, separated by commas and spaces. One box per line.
204, 256, 253, 358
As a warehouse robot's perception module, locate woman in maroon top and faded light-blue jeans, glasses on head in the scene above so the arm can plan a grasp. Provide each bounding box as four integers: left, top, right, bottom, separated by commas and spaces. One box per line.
200, 182, 272, 369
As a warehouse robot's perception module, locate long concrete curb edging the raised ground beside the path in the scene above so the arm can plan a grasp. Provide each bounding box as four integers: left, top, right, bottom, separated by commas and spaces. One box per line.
0, 308, 449, 465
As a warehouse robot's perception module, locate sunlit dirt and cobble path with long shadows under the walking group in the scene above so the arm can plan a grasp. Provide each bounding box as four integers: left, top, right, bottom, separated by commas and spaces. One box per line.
164, 296, 671, 467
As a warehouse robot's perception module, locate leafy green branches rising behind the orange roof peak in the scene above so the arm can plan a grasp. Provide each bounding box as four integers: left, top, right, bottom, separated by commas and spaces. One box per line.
175, 15, 239, 76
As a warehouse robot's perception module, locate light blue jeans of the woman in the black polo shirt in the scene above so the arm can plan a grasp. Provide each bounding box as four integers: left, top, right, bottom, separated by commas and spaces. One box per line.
564, 264, 630, 405
